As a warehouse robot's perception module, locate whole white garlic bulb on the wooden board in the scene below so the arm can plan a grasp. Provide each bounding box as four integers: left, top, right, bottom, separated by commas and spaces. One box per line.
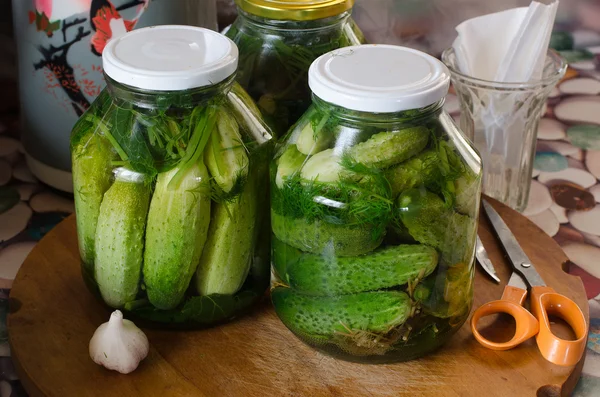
90, 310, 150, 374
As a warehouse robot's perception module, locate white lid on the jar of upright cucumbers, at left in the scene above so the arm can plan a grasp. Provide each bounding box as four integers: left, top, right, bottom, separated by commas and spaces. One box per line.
102, 25, 238, 91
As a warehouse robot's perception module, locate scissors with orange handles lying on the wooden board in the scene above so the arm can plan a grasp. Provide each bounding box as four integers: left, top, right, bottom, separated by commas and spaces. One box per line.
471, 200, 588, 366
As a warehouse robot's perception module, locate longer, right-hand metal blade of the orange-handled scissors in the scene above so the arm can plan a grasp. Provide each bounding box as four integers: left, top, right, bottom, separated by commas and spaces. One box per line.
481, 199, 546, 287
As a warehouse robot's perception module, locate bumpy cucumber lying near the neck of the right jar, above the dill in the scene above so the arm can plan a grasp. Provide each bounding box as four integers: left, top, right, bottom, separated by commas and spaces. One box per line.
348, 126, 429, 168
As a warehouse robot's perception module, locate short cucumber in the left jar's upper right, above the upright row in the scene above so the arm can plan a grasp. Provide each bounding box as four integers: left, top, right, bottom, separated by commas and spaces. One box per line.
204, 111, 248, 193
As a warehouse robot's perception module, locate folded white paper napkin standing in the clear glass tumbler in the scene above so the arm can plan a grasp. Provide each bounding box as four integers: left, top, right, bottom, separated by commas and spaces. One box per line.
452, 0, 558, 82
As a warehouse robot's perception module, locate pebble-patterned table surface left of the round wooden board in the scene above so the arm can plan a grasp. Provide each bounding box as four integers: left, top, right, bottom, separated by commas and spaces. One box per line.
0, 115, 74, 397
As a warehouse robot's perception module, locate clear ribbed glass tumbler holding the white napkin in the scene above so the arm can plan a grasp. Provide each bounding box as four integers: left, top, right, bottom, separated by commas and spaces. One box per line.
442, 48, 567, 211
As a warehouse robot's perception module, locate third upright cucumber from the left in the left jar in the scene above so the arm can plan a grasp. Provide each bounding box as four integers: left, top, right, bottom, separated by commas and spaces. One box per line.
143, 161, 211, 310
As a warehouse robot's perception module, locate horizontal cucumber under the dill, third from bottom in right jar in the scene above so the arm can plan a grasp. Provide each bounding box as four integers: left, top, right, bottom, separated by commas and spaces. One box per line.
271, 211, 384, 256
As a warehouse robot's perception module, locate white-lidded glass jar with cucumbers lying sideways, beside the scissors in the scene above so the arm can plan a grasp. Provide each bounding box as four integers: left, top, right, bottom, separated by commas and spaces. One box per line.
271, 45, 481, 362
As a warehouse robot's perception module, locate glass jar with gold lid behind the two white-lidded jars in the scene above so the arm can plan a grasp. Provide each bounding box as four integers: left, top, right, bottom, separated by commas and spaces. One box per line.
226, 0, 364, 136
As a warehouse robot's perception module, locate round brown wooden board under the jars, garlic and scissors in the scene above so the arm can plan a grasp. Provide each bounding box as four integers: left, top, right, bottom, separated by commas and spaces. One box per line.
8, 203, 589, 397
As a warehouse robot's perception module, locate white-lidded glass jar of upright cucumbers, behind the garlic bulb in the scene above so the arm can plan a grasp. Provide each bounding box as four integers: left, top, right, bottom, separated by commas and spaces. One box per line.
71, 26, 272, 326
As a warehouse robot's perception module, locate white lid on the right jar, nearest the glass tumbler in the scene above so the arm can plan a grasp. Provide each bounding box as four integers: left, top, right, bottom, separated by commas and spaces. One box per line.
308, 44, 450, 113
